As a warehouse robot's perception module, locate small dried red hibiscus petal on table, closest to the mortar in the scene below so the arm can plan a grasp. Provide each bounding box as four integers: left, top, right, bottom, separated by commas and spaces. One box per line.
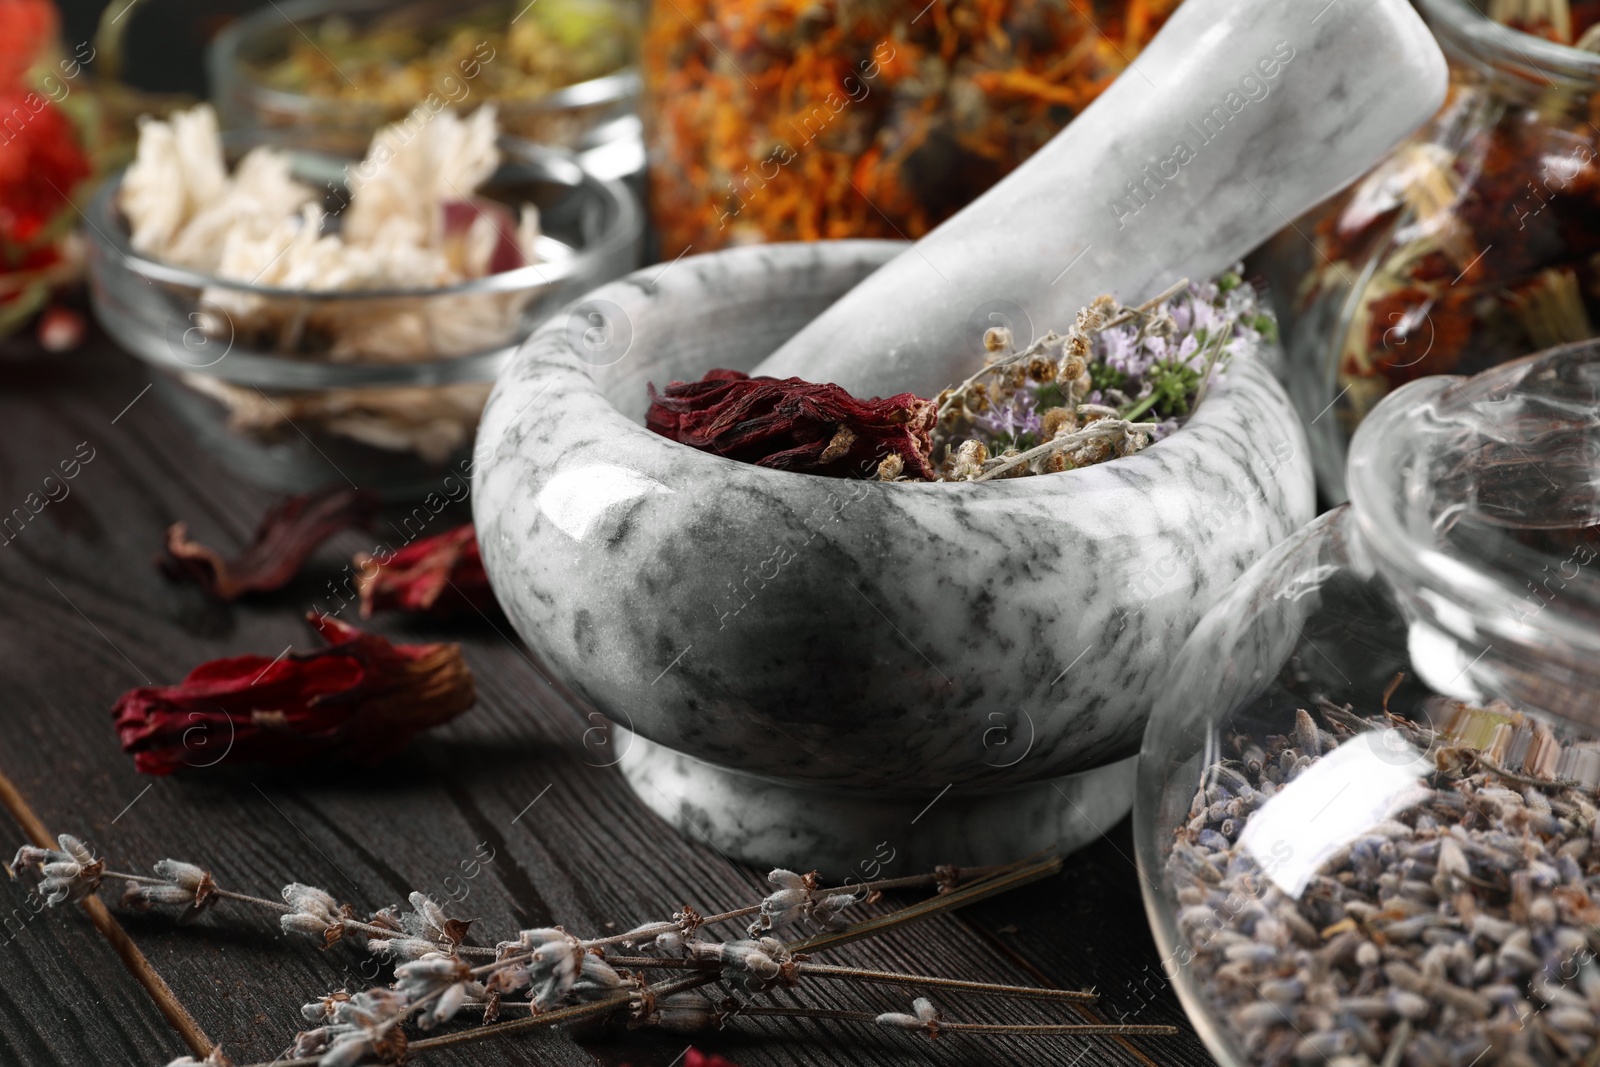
355, 523, 494, 619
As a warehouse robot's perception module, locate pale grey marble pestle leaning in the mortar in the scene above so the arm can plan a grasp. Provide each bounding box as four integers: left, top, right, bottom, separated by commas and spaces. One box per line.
754, 0, 1445, 397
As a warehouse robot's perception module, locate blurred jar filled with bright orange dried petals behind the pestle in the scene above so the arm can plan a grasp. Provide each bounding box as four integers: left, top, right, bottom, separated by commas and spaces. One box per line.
643, 0, 1178, 258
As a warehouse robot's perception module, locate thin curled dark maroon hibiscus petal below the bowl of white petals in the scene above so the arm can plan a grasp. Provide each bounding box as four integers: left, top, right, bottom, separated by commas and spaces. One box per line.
162, 486, 378, 600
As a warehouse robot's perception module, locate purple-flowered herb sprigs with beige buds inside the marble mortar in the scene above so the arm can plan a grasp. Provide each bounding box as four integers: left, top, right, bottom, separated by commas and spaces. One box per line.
928, 267, 1277, 482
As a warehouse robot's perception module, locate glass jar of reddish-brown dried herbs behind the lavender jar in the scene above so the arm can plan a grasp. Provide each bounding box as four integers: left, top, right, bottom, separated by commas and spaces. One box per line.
1261, 0, 1600, 502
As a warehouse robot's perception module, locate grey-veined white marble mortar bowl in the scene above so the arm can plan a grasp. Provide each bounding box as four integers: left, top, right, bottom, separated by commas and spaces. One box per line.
474, 242, 1314, 861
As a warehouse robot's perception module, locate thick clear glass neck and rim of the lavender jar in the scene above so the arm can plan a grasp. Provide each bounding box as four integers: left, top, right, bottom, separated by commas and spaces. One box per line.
1347, 341, 1600, 726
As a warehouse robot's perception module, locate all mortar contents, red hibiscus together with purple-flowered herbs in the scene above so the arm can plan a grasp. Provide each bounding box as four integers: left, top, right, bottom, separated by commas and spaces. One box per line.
645, 269, 1277, 482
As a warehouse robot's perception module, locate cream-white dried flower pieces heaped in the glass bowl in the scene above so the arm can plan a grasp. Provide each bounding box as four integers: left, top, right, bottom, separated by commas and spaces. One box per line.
118, 104, 539, 461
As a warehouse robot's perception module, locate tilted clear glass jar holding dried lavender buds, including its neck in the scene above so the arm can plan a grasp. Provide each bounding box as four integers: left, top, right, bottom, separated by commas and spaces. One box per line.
1134, 341, 1600, 1067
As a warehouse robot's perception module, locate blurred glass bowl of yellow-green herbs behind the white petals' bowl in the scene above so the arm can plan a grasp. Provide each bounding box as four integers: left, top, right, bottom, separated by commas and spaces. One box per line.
208, 0, 645, 179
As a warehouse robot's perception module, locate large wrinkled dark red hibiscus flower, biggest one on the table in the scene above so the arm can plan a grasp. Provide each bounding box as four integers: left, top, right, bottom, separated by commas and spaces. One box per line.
114, 613, 477, 774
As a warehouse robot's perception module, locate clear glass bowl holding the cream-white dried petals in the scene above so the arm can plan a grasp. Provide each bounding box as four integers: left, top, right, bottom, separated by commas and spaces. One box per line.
86, 131, 643, 499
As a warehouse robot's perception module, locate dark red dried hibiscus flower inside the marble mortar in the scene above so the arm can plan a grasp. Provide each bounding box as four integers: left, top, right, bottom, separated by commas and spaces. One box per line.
645, 371, 938, 480
